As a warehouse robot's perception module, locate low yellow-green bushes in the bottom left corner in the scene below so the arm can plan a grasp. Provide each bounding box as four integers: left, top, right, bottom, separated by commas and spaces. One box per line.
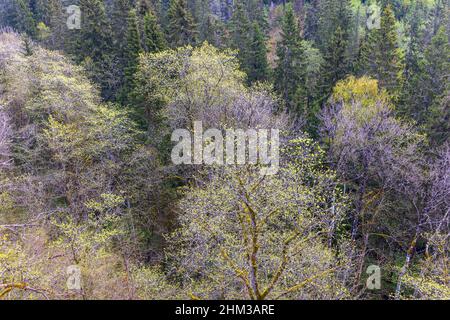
0, 194, 129, 299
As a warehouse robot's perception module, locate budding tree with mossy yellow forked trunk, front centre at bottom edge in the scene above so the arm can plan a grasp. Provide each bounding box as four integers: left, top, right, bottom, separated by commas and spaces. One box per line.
168, 138, 350, 299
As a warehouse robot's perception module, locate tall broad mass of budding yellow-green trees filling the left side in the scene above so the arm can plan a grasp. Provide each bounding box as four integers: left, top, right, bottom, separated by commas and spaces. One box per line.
0, 33, 141, 299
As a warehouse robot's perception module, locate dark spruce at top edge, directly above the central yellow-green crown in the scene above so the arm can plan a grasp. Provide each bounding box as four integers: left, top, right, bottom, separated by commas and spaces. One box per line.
167, 0, 197, 47
